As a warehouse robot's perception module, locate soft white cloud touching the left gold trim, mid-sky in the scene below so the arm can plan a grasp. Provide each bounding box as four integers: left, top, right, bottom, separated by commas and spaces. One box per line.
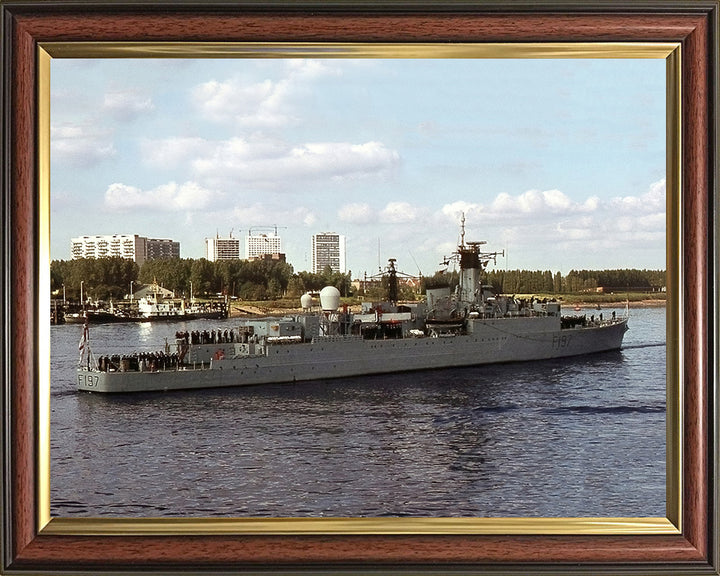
50, 124, 116, 167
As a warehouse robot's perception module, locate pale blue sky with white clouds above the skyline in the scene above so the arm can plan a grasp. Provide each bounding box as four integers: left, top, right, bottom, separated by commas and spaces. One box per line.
51, 58, 666, 278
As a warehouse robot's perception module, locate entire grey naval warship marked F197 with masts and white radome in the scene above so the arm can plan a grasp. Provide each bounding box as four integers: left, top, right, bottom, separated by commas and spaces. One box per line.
77, 222, 629, 393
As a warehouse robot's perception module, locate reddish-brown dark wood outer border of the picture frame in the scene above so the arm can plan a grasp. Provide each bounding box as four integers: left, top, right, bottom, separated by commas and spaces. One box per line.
0, 0, 720, 574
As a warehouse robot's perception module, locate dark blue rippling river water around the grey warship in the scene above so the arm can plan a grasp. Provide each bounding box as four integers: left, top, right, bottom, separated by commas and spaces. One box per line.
51, 308, 666, 517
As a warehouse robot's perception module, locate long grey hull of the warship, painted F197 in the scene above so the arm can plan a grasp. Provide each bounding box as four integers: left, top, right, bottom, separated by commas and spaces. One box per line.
77, 318, 627, 393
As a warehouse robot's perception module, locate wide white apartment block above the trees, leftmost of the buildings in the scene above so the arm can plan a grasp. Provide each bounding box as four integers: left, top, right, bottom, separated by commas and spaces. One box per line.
70, 234, 180, 266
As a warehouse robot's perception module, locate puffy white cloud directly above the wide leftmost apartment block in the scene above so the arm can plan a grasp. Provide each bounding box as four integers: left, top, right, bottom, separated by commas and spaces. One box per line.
105, 182, 218, 212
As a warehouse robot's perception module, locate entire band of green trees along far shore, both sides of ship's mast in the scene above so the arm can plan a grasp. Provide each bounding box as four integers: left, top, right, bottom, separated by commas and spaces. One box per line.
50, 256, 666, 301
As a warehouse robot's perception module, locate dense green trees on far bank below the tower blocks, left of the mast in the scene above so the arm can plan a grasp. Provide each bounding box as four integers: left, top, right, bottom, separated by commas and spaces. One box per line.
50, 256, 350, 301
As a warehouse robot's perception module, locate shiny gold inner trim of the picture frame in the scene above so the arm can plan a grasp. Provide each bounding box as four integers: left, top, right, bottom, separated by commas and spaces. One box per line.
36, 42, 683, 536
